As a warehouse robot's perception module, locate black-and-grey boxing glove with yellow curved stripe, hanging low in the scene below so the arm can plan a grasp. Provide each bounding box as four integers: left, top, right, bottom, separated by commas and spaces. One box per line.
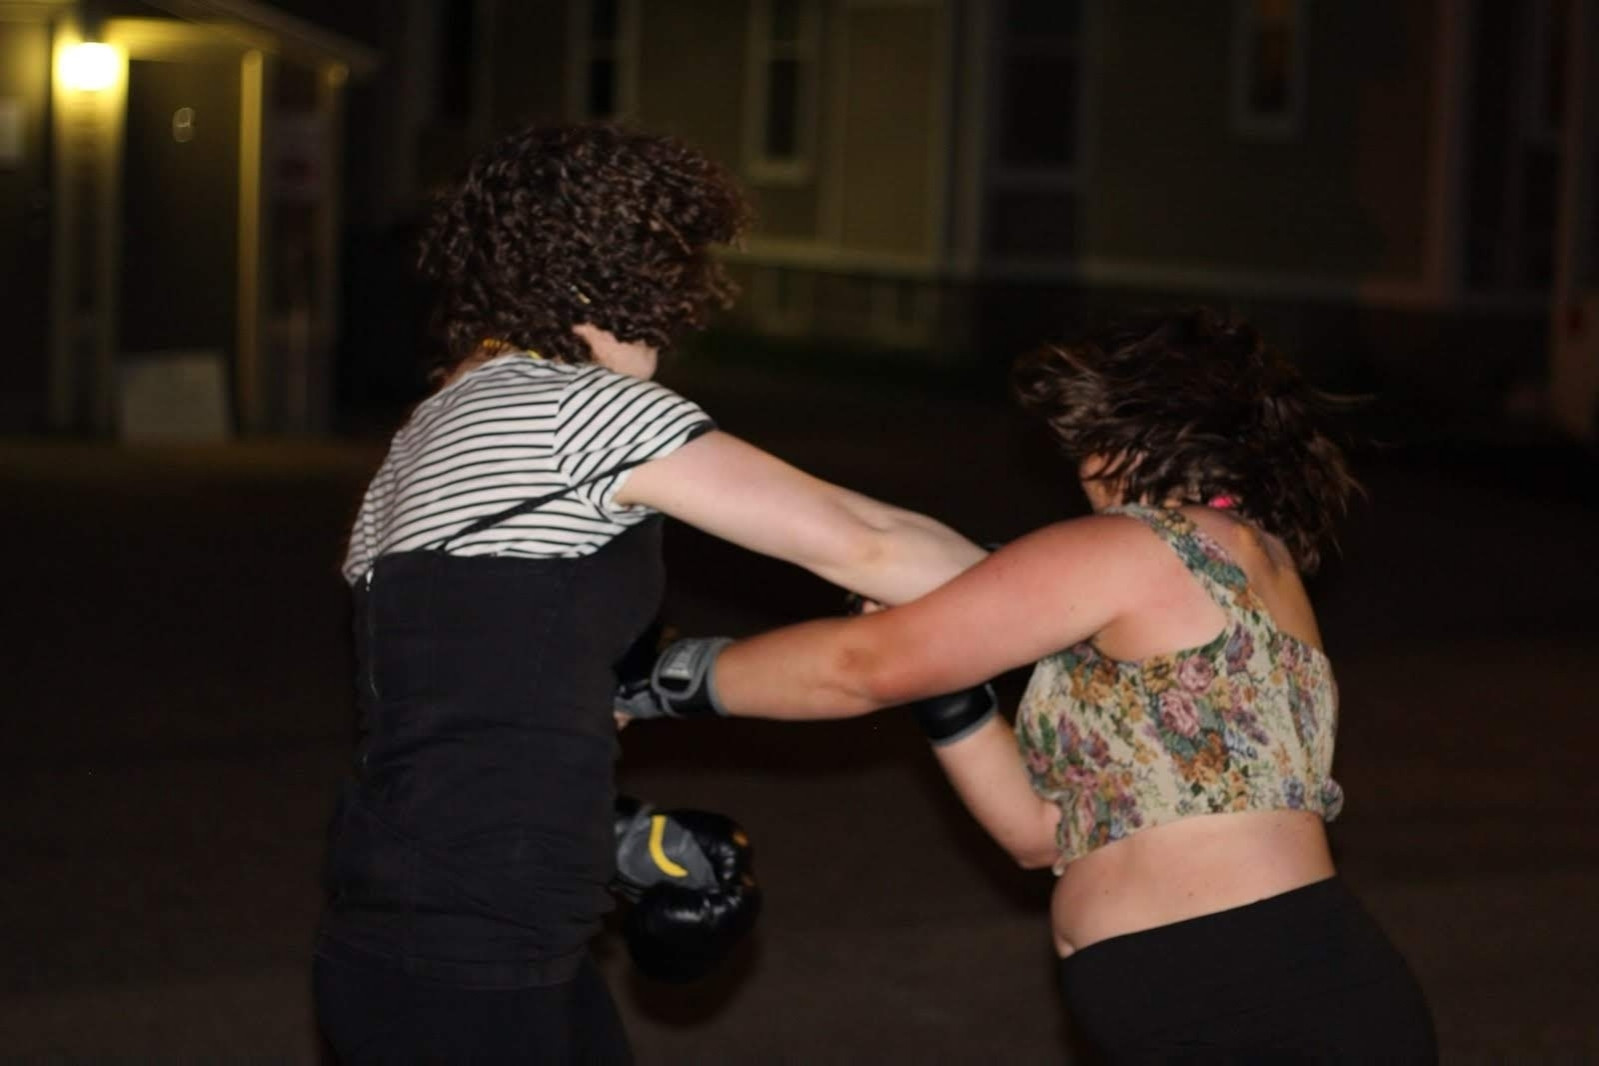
616, 798, 761, 981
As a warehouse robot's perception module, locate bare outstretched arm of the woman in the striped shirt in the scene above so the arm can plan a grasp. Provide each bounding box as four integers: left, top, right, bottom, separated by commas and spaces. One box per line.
616, 432, 985, 604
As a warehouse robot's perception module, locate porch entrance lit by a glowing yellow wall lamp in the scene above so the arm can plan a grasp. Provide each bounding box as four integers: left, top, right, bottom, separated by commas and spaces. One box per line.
0, 0, 377, 436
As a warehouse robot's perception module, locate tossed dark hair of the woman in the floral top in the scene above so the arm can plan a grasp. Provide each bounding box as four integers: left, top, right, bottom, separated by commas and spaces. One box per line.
1012, 308, 1361, 574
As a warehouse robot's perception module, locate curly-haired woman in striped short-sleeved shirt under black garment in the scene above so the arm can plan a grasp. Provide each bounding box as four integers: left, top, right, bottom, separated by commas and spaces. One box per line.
313, 126, 983, 1063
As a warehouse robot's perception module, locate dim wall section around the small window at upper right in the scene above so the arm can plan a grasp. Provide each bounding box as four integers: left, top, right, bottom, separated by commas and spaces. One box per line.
1078, 0, 1438, 280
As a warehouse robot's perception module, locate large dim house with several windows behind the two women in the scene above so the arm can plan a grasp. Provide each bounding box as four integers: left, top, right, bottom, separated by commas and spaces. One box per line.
353, 0, 1599, 438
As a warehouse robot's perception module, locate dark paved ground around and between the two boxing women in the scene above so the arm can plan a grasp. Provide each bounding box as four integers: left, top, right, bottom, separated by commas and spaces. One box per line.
0, 362, 1599, 1066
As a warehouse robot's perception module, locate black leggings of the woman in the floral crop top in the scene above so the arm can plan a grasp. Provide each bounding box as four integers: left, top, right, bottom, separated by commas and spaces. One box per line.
1060, 877, 1438, 1066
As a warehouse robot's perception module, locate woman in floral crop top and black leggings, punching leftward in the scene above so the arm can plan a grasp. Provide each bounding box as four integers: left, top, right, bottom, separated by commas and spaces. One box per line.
627, 312, 1436, 1063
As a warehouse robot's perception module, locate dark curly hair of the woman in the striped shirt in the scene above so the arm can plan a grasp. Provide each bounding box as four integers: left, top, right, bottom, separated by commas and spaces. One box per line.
417, 125, 748, 371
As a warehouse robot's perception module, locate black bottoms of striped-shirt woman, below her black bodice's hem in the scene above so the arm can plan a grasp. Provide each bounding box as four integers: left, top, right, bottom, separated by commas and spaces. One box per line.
312, 954, 633, 1066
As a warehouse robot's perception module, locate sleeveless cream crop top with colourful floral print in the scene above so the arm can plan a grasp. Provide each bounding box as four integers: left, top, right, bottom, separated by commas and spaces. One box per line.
1015, 505, 1343, 876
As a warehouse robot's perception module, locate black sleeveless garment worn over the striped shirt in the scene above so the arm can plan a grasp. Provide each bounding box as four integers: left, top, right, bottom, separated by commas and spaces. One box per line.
318, 508, 665, 989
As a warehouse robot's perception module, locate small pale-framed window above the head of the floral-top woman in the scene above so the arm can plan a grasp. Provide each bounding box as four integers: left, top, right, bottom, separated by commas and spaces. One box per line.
1233, 0, 1305, 139
